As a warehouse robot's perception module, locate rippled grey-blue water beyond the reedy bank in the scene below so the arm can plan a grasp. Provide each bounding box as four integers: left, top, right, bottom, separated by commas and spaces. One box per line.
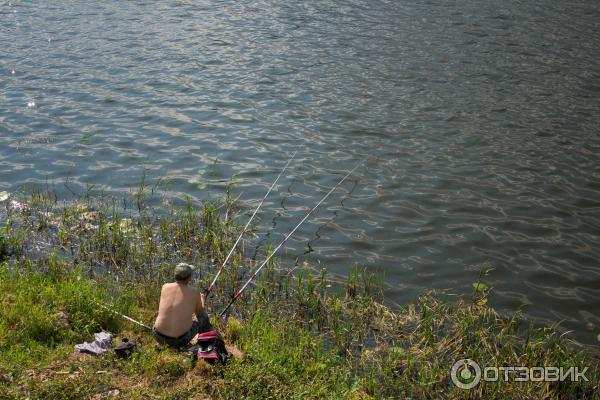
0, 0, 600, 343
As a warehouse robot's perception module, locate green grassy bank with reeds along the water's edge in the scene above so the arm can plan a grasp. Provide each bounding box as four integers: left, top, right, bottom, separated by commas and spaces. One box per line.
0, 193, 599, 399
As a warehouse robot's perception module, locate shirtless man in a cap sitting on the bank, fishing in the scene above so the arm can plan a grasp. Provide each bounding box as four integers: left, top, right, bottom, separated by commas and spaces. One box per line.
153, 263, 210, 347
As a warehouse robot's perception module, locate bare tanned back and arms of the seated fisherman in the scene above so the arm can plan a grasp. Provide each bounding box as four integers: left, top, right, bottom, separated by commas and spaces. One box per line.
154, 282, 204, 338
